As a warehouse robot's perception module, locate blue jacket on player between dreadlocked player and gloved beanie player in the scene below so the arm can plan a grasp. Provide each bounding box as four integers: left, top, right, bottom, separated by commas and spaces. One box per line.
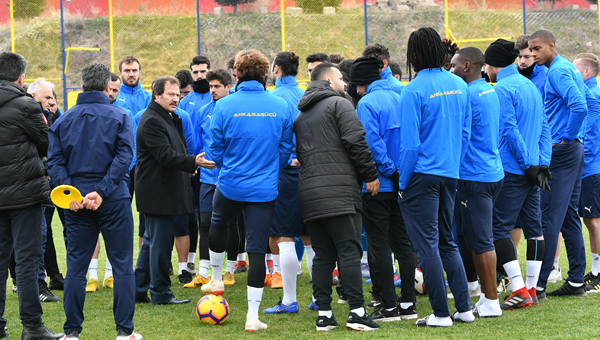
460, 79, 504, 183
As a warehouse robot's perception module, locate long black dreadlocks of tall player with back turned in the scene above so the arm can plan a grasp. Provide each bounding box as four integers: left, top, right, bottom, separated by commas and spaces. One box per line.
406, 27, 446, 80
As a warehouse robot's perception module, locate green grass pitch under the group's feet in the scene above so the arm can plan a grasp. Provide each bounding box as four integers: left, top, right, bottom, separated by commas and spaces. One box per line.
4, 203, 600, 340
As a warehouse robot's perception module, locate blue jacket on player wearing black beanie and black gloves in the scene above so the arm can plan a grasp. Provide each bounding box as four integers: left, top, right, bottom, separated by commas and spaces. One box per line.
494, 65, 552, 175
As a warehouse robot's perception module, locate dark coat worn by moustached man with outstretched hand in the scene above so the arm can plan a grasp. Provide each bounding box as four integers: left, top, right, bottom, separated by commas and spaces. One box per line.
135, 101, 196, 215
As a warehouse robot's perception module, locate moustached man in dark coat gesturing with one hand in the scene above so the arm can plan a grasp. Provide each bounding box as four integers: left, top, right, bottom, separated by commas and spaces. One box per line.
135, 77, 215, 304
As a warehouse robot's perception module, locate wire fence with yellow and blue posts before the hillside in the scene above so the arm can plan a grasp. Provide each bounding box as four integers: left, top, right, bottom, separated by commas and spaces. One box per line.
0, 0, 600, 107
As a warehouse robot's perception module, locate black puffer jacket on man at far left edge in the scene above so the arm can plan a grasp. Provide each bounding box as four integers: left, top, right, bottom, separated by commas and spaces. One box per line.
0, 80, 50, 210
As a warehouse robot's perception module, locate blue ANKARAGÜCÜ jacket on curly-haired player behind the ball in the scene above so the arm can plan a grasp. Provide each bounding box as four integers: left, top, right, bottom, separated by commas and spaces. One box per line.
208, 80, 293, 202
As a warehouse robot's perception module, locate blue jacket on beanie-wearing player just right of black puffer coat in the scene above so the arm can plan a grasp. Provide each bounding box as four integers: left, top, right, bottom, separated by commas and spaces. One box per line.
357, 79, 400, 193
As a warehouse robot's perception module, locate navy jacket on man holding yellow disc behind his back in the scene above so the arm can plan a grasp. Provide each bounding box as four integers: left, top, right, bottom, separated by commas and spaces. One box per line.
47, 91, 133, 201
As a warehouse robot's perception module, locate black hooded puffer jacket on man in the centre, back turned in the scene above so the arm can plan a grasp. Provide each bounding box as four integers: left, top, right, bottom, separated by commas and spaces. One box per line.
294, 80, 377, 222
